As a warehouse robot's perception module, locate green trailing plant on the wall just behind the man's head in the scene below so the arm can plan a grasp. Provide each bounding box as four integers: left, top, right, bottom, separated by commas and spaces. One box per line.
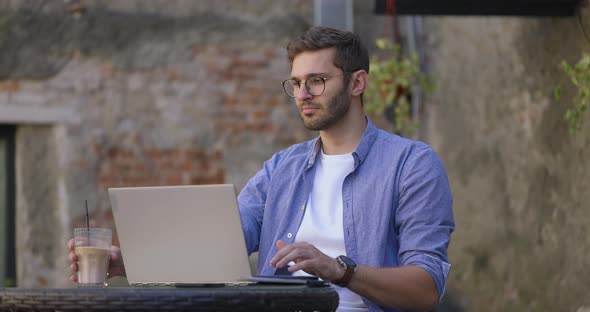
364, 39, 434, 135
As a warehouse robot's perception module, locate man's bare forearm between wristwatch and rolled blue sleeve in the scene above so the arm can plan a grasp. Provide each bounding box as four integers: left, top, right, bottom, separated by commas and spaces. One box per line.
348, 265, 438, 311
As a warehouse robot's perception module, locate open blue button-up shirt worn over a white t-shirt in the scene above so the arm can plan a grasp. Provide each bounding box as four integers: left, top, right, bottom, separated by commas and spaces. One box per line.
238, 118, 455, 311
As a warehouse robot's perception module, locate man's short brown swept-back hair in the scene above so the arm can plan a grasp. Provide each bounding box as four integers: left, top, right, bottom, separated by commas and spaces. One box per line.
287, 26, 369, 76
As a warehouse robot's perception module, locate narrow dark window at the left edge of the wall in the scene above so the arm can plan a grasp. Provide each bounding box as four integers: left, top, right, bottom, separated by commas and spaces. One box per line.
0, 125, 16, 287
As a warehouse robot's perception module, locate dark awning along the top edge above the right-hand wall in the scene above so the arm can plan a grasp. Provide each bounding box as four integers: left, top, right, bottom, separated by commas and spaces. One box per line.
375, 0, 582, 16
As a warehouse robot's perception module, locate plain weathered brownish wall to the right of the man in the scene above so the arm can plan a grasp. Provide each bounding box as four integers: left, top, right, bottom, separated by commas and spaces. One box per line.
424, 9, 590, 311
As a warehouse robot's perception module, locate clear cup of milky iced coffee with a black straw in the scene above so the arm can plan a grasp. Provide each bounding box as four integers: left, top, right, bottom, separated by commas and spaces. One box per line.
74, 228, 113, 287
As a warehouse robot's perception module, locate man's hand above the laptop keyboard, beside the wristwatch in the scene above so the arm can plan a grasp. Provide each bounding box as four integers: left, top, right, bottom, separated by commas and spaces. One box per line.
270, 240, 344, 281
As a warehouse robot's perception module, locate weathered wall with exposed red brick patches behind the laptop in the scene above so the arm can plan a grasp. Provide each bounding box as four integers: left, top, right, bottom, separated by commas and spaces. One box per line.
0, 0, 313, 287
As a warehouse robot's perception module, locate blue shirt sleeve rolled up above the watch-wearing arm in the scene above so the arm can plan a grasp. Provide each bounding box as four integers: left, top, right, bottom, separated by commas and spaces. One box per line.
395, 147, 455, 299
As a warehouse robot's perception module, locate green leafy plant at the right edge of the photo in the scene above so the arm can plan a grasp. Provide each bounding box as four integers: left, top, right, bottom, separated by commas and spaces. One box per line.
555, 53, 590, 135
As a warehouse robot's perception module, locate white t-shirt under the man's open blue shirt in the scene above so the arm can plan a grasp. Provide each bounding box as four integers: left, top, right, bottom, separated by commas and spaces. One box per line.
293, 151, 368, 312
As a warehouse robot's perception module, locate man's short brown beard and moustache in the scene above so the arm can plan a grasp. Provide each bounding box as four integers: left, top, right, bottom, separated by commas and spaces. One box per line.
299, 88, 350, 131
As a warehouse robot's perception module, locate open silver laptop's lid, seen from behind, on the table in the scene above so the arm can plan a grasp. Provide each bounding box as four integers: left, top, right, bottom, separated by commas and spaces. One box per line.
108, 184, 251, 286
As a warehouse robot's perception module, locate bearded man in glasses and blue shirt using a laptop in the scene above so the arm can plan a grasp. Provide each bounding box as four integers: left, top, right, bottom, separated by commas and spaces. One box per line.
69, 27, 454, 311
